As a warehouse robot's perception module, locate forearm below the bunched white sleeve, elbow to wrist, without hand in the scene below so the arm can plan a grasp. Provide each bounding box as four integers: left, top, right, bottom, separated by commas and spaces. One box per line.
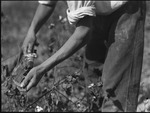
40, 17, 92, 71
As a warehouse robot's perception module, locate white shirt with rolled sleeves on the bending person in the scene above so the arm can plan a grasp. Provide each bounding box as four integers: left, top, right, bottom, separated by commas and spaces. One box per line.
39, 0, 127, 24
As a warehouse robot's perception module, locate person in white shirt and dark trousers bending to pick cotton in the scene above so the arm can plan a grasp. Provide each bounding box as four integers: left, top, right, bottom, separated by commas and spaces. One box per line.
2, 0, 145, 112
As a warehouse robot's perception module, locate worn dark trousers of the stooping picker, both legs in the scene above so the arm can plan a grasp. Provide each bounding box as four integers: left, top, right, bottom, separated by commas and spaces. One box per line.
84, 1, 146, 112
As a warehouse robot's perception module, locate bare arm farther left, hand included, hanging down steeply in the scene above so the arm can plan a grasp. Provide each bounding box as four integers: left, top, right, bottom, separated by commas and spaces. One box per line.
22, 0, 57, 54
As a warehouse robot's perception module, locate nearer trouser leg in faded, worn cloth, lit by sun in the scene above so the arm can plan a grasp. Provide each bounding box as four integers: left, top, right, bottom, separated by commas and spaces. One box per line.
102, 2, 145, 112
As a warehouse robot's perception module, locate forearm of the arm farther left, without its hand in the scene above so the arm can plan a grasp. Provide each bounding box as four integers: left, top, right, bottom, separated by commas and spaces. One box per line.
28, 2, 56, 34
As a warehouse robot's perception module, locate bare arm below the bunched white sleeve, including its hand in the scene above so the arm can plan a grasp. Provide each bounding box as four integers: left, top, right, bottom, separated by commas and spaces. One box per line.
20, 16, 93, 91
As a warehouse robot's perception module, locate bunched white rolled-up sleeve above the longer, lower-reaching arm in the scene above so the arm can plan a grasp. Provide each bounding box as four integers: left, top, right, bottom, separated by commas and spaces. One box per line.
67, 0, 96, 25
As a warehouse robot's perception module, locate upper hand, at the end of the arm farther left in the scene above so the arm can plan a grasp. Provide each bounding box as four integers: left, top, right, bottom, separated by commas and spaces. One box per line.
22, 33, 36, 55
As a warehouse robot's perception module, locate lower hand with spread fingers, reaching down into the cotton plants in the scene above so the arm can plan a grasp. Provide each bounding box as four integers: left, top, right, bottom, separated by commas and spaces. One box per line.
20, 66, 44, 92
